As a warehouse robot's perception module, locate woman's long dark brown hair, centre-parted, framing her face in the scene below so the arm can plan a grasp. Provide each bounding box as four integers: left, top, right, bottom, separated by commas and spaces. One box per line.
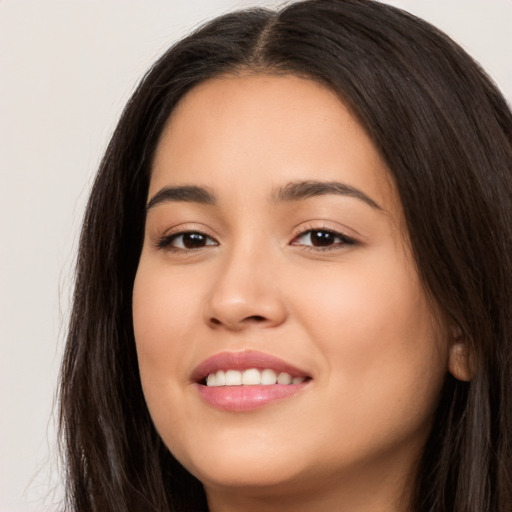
60, 0, 512, 512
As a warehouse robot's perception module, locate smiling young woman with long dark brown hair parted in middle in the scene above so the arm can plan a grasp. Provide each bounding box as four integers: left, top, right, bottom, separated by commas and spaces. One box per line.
61, 0, 512, 512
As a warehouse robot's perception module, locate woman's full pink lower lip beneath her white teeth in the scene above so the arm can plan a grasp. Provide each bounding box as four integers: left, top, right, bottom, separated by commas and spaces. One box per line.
197, 382, 307, 411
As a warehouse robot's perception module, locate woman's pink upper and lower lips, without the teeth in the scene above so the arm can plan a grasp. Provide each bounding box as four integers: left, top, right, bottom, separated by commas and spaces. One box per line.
192, 351, 310, 412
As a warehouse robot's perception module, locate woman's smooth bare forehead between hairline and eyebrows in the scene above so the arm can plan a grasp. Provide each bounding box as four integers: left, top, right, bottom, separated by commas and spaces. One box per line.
149, 74, 396, 207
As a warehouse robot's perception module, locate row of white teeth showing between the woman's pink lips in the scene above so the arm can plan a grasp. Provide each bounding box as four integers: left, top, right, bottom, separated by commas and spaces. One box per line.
201, 368, 310, 387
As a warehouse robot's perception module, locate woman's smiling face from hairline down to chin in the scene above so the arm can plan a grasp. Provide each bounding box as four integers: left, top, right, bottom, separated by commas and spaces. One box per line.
133, 74, 448, 506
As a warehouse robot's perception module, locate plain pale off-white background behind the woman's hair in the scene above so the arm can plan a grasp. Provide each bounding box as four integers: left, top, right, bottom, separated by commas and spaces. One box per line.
0, 0, 512, 512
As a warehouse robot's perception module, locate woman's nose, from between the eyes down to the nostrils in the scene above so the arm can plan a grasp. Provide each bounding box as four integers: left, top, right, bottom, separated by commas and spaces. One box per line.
204, 245, 287, 331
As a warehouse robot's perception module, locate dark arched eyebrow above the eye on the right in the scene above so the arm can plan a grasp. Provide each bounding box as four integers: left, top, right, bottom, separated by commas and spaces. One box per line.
273, 181, 382, 210
